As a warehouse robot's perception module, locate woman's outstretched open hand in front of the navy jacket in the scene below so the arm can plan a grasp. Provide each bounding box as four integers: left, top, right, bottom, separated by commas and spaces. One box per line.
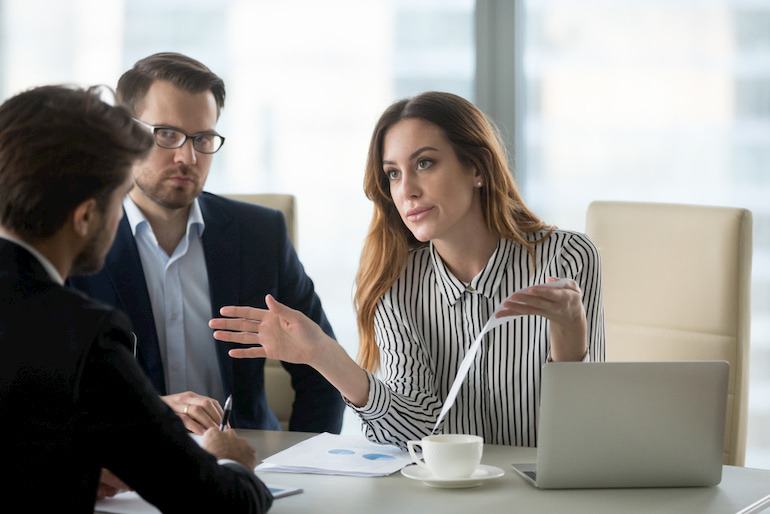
209, 295, 328, 367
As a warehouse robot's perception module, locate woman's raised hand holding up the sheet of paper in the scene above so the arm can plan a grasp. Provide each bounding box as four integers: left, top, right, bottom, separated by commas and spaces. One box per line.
497, 277, 586, 361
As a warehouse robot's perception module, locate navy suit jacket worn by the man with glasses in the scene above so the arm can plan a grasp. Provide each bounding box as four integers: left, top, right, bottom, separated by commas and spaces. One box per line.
69, 193, 344, 433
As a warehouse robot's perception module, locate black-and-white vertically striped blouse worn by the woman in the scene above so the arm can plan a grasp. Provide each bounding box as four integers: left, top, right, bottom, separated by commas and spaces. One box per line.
354, 229, 605, 448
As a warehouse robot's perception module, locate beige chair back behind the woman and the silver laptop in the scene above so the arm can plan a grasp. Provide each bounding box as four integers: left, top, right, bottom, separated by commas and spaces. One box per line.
586, 202, 752, 466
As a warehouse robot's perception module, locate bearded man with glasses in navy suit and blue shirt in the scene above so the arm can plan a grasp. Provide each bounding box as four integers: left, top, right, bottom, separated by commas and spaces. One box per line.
70, 53, 344, 433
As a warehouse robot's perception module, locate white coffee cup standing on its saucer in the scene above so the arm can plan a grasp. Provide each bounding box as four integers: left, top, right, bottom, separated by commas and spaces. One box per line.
406, 434, 484, 478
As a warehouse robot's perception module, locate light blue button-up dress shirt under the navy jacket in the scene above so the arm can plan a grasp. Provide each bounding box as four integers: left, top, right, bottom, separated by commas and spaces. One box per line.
123, 196, 225, 405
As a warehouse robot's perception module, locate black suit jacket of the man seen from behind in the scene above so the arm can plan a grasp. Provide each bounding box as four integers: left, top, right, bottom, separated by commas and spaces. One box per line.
0, 239, 272, 513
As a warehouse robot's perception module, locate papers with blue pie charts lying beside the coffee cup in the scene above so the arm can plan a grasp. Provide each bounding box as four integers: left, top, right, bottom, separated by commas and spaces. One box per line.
257, 433, 412, 477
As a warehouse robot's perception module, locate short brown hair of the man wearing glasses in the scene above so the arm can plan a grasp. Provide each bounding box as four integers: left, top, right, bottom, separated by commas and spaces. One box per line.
116, 52, 225, 116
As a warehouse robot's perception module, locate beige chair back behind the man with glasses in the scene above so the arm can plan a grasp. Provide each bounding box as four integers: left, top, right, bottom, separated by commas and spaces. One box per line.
222, 194, 297, 430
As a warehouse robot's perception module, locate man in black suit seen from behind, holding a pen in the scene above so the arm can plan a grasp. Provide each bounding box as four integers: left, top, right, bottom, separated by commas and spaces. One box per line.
0, 86, 272, 512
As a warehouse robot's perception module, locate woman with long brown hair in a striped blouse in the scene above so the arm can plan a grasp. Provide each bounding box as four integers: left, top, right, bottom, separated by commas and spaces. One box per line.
210, 92, 604, 447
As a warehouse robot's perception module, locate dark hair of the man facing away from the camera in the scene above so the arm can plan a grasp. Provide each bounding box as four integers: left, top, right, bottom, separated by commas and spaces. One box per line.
0, 86, 154, 239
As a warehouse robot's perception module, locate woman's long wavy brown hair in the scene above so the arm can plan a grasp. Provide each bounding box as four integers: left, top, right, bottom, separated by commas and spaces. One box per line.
354, 92, 551, 373
